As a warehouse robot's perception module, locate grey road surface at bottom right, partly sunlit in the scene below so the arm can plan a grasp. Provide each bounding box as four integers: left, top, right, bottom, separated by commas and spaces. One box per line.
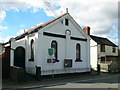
30, 75, 120, 90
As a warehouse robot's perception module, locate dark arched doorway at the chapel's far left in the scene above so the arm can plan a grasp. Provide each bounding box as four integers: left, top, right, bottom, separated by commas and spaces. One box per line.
14, 46, 25, 69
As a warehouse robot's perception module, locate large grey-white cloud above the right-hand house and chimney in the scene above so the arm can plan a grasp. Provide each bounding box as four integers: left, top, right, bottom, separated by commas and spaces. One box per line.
59, 0, 118, 34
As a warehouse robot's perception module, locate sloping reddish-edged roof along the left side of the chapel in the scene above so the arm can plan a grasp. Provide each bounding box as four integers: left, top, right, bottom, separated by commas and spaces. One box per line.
15, 13, 69, 40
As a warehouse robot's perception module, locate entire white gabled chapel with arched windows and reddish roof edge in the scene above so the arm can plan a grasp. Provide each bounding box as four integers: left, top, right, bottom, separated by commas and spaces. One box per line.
10, 13, 91, 75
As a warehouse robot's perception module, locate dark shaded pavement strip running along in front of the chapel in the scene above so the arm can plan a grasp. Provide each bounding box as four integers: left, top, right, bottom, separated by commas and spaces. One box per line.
2, 72, 119, 90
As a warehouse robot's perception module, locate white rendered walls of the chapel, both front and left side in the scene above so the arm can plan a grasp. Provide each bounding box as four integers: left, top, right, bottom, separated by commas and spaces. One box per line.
11, 15, 90, 75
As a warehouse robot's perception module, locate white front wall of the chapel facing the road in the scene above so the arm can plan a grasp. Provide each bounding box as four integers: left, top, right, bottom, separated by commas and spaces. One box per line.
34, 15, 90, 75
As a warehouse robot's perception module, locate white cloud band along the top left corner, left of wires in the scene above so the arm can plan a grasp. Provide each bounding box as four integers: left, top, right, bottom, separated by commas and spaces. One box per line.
0, 0, 44, 12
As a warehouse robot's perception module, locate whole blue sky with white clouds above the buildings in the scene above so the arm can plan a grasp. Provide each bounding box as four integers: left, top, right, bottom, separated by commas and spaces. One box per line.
0, 0, 118, 44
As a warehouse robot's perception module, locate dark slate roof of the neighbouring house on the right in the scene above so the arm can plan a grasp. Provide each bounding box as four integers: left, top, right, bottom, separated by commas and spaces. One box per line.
90, 35, 117, 47
